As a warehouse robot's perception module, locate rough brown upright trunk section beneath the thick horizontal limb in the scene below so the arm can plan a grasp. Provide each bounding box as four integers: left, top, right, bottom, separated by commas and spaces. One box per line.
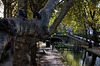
13, 37, 35, 66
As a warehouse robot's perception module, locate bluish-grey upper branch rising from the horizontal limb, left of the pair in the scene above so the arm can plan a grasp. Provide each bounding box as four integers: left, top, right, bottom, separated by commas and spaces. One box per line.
39, 0, 59, 34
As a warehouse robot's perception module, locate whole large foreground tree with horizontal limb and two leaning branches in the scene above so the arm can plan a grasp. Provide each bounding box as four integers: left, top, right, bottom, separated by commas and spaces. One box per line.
0, 0, 73, 66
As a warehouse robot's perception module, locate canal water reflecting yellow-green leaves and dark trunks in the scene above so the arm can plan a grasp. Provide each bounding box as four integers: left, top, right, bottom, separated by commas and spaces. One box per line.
55, 43, 100, 66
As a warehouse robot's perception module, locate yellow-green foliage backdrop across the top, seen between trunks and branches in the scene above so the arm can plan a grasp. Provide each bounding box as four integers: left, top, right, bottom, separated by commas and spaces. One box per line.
0, 0, 100, 34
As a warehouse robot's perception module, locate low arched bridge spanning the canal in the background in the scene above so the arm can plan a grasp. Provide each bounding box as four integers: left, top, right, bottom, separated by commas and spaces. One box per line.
47, 35, 88, 45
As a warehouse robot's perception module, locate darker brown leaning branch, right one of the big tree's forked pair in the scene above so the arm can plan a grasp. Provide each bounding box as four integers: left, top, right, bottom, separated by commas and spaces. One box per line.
50, 0, 74, 34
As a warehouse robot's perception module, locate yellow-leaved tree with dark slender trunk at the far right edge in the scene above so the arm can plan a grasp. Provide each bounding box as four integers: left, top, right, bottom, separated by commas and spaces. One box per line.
84, 0, 100, 46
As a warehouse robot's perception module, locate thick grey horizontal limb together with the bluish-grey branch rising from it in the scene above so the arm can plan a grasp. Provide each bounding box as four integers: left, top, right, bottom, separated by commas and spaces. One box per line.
0, 0, 59, 44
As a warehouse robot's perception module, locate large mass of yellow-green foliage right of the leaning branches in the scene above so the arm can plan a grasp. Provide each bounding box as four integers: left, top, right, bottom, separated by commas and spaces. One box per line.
60, 0, 100, 34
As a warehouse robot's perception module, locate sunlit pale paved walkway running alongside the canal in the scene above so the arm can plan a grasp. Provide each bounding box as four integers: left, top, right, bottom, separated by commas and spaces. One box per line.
38, 43, 64, 66
